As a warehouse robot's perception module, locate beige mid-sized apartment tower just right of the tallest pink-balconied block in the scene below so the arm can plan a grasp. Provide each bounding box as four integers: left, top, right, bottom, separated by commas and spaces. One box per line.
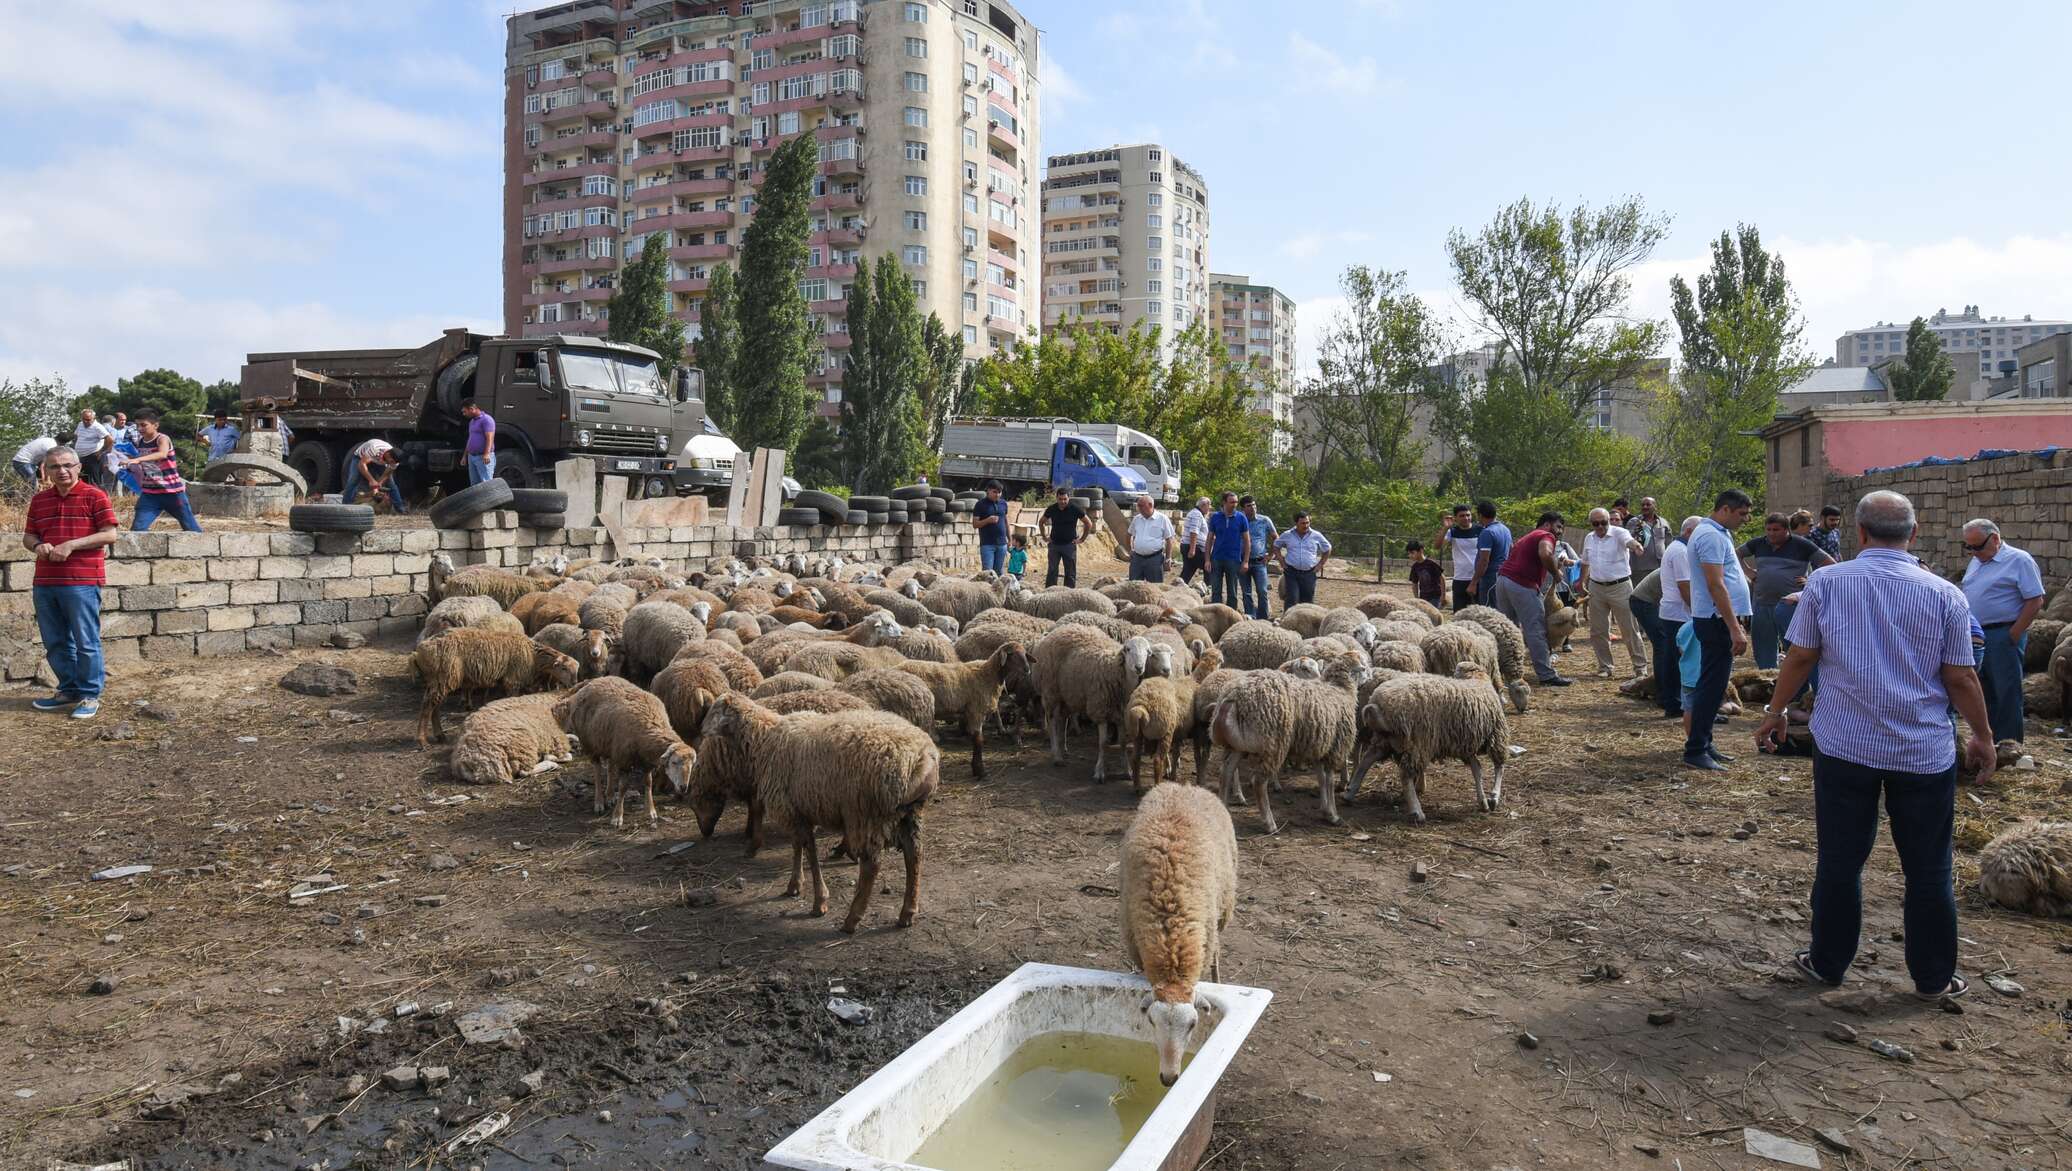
1042, 143, 1210, 338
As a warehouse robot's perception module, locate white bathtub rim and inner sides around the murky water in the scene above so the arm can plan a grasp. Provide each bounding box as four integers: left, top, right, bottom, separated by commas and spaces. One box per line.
762, 964, 1274, 1171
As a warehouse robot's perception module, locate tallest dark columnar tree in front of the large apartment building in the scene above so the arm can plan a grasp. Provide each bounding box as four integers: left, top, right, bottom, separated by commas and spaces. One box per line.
731, 135, 818, 450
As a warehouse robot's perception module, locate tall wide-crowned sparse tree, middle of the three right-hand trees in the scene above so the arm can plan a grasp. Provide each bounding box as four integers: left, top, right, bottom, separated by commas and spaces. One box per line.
1446, 199, 1668, 495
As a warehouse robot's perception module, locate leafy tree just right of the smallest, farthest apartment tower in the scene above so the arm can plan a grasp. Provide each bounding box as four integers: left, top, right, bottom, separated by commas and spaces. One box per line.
1297, 265, 1440, 487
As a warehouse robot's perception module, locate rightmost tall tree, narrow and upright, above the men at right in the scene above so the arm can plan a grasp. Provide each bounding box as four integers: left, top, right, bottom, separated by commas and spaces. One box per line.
1658, 224, 1813, 514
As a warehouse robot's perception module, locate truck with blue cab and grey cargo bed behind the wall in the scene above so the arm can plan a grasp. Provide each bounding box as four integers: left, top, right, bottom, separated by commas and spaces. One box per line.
941, 417, 1179, 504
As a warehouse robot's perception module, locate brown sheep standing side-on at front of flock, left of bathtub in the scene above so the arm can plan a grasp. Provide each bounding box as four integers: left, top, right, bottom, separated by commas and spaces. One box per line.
700, 694, 943, 935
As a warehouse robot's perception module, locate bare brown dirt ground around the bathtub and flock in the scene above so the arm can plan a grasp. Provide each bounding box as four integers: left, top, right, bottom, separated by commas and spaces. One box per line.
0, 559, 2072, 1171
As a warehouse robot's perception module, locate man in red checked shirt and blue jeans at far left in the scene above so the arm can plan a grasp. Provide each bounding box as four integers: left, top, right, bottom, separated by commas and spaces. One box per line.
21, 448, 116, 719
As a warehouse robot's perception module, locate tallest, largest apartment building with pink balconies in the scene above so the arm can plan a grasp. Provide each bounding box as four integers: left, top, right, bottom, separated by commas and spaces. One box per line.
503, 0, 1040, 415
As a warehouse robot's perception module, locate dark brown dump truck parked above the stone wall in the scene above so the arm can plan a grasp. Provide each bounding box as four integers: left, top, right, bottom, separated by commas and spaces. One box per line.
240, 330, 704, 497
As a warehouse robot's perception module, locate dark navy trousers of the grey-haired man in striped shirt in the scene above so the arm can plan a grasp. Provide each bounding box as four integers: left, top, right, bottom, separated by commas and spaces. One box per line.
1811, 754, 1956, 993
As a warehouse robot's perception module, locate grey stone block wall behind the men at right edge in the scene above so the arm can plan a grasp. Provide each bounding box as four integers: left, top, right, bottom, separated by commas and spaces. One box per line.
1828, 452, 2072, 591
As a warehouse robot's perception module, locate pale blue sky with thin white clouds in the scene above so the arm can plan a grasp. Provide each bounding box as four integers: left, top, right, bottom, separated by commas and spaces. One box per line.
0, 0, 2072, 390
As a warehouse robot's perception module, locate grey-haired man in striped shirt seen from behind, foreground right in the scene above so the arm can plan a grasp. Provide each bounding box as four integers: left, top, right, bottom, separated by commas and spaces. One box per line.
1755, 491, 1993, 1001
